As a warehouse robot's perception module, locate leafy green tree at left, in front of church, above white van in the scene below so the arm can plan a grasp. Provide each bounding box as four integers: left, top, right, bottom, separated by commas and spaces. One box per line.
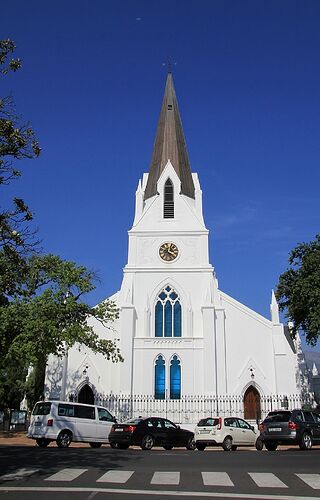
0, 255, 123, 410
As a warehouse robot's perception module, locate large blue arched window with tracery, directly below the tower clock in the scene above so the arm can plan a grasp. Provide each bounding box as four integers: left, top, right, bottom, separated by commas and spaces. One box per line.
155, 286, 181, 337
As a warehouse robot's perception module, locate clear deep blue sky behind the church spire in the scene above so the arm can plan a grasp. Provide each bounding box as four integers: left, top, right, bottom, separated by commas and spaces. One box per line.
1, 0, 320, 348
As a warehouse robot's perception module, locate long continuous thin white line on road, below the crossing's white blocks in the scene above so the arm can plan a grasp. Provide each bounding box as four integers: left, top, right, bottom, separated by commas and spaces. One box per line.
0, 486, 320, 500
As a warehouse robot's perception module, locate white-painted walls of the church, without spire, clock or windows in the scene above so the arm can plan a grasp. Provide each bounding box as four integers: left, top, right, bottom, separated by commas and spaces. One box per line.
46, 73, 298, 418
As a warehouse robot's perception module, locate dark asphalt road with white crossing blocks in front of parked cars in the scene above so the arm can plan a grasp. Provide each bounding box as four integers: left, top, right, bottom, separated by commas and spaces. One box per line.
0, 446, 320, 500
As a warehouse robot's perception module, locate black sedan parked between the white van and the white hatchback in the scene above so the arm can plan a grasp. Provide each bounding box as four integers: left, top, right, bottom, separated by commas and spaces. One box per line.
109, 417, 195, 450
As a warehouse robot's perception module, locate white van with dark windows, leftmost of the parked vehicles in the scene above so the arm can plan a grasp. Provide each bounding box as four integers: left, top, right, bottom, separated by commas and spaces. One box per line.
27, 401, 116, 448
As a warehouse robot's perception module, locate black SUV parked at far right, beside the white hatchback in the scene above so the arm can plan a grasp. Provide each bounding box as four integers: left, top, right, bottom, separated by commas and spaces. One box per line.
259, 410, 320, 451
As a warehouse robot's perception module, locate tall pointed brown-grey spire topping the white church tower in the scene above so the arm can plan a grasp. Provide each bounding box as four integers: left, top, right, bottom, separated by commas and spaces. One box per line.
144, 72, 195, 200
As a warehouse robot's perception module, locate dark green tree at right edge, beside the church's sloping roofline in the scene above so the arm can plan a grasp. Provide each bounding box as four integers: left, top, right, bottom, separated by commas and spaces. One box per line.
276, 234, 320, 346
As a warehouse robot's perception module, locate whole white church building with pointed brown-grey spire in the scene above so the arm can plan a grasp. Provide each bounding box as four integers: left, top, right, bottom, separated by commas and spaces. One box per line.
45, 73, 301, 422
